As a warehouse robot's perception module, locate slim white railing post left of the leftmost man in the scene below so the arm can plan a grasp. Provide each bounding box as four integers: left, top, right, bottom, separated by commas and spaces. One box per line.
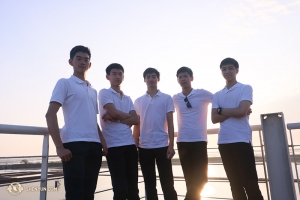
40, 134, 49, 200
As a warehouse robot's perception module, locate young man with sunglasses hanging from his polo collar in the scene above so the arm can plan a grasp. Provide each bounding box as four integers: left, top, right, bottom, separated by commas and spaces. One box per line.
173, 67, 213, 200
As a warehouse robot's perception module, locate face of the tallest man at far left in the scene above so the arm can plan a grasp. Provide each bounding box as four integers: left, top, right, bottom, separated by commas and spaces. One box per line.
69, 51, 91, 74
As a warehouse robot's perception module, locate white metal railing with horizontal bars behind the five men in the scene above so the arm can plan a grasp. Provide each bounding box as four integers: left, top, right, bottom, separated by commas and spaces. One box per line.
0, 123, 300, 200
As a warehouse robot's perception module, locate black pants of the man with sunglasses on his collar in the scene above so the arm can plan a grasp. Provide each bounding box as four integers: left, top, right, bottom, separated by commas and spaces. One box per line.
177, 141, 208, 200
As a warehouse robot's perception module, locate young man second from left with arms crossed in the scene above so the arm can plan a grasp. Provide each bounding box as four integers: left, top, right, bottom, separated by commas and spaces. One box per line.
99, 63, 140, 200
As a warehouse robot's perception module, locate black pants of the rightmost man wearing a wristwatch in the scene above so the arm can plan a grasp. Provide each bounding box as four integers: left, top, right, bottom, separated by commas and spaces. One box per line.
219, 142, 263, 200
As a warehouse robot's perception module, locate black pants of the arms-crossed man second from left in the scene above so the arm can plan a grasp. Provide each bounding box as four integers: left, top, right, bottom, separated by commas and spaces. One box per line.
106, 145, 140, 200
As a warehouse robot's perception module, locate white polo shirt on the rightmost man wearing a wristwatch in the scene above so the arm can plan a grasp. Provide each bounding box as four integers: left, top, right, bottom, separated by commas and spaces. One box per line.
212, 83, 252, 144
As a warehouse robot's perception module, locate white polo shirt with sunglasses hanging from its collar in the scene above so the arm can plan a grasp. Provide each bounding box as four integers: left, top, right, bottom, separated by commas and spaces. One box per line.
173, 89, 213, 142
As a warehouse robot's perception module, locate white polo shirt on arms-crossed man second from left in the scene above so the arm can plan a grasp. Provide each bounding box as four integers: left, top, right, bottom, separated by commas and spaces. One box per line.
98, 88, 135, 148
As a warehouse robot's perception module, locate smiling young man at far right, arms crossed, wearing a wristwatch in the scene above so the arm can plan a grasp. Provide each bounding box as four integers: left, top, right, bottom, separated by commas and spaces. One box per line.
211, 58, 263, 200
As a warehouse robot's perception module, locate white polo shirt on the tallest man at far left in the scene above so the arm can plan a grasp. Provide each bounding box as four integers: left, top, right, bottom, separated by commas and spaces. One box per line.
50, 75, 100, 143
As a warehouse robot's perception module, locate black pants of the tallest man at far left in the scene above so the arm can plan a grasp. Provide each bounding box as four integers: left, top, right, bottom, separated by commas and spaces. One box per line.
62, 142, 102, 200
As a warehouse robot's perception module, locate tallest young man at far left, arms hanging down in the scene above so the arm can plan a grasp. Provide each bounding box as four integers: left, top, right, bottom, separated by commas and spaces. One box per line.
46, 46, 107, 200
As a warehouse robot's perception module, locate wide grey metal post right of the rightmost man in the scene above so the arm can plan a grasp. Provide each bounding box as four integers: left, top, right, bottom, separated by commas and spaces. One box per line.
261, 113, 296, 200
